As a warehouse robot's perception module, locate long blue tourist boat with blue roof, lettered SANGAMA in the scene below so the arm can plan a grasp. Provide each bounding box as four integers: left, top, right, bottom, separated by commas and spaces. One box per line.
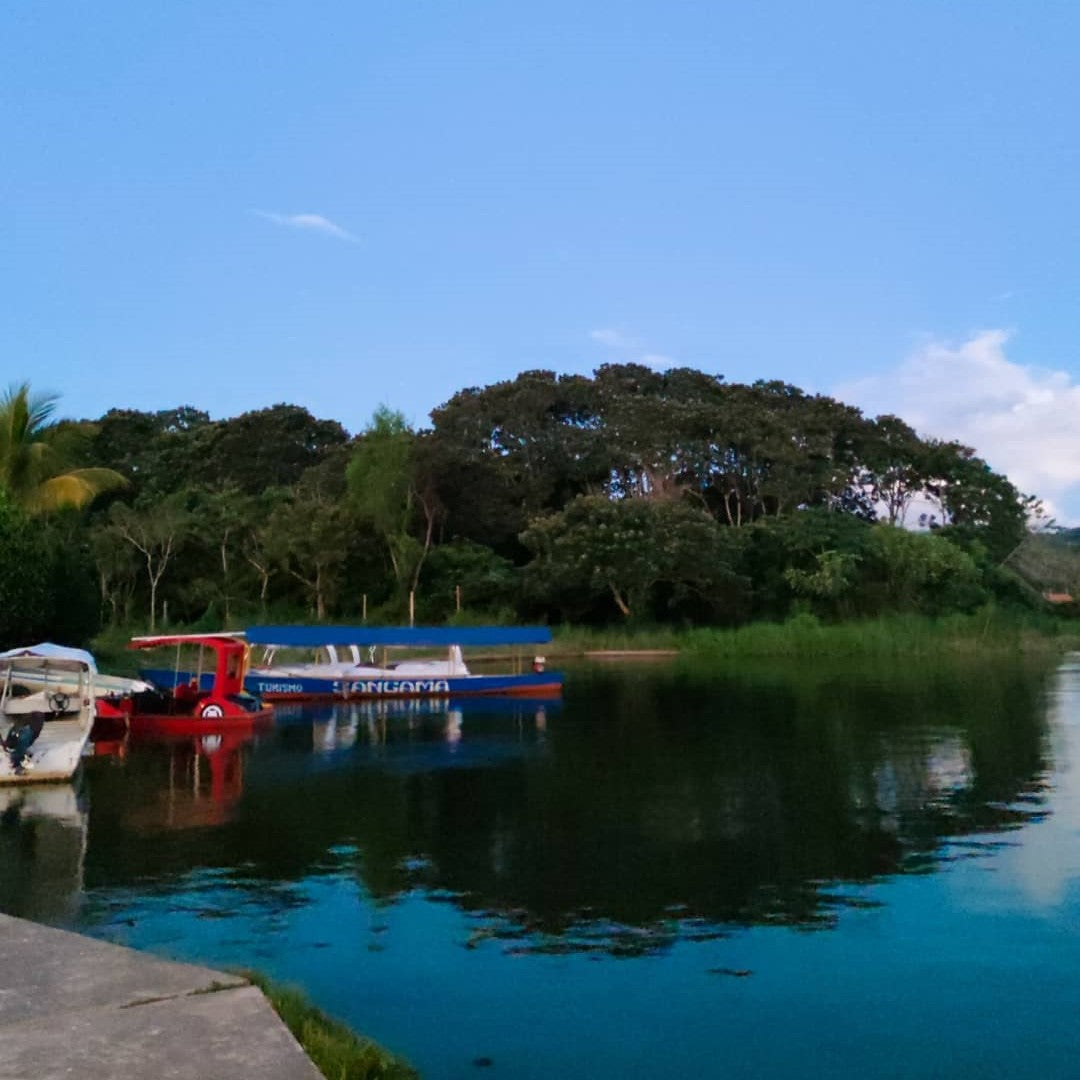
144, 626, 563, 701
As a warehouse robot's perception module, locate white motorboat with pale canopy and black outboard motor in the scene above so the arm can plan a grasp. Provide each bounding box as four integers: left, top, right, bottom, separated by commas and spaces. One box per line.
0, 645, 97, 784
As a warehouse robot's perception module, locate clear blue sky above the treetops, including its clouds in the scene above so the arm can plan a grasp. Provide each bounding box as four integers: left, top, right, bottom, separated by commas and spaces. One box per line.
6, 0, 1080, 513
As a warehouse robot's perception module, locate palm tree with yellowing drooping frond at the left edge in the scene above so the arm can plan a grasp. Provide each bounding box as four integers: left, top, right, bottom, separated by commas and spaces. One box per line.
0, 382, 126, 514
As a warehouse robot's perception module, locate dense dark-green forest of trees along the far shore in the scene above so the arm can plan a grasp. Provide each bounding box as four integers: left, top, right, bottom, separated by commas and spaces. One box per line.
0, 364, 1058, 642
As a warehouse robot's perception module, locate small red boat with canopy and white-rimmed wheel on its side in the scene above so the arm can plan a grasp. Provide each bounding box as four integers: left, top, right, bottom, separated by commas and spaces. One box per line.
124, 634, 273, 735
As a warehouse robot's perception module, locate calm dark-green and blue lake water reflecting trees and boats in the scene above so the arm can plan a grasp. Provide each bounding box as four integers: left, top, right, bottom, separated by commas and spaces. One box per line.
0, 662, 1080, 1080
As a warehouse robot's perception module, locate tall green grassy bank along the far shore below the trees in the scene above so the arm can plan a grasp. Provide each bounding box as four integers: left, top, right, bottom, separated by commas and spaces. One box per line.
551, 609, 1080, 660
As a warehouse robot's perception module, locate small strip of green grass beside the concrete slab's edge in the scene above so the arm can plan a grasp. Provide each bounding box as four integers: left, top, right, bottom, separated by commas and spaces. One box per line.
243, 971, 419, 1080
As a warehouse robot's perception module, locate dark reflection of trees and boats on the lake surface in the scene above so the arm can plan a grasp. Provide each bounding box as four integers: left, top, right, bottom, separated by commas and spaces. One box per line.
65, 667, 1049, 955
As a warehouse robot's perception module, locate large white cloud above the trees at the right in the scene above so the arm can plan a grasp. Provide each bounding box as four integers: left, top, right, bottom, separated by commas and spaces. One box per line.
835, 329, 1080, 519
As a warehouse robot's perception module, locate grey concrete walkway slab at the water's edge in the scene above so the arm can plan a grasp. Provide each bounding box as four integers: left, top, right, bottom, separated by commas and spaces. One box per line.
0, 915, 322, 1080
